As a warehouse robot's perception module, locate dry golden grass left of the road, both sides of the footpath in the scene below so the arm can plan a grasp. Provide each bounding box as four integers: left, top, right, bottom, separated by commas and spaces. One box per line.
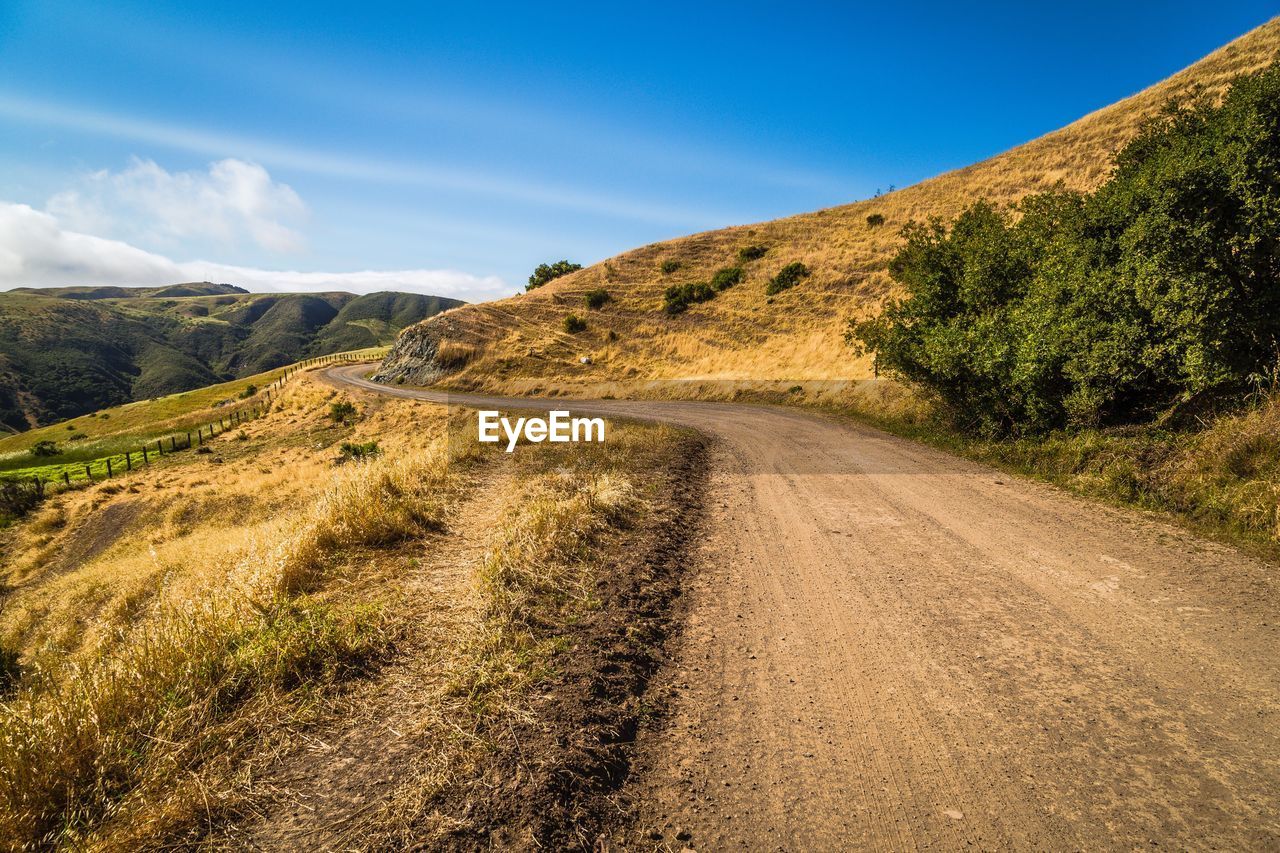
0, 377, 691, 850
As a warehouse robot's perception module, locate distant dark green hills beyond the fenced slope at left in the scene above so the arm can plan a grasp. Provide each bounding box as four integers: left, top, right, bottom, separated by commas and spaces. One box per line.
0, 282, 462, 430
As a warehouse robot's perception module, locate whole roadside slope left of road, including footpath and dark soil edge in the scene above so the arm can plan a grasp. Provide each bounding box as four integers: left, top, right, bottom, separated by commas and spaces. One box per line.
0, 373, 699, 850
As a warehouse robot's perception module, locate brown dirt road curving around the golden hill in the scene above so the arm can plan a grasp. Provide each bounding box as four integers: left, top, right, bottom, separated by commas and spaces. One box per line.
330, 366, 1280, 849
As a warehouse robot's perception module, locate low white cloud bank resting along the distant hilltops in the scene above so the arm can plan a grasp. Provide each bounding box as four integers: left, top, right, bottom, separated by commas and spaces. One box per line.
0, 202, 513, 302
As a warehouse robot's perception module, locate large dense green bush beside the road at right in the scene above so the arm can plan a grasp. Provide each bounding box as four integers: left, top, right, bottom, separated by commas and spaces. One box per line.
850, 64, 1280, 435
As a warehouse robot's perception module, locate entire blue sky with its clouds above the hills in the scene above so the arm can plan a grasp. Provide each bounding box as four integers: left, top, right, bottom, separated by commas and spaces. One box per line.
0, 0, 1275, 298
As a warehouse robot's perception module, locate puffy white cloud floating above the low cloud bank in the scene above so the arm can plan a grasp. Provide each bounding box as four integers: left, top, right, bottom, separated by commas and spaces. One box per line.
46, 158, 307, 252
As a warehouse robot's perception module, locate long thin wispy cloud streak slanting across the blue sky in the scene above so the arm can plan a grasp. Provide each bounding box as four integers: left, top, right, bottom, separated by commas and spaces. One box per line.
0, 93, 732, 228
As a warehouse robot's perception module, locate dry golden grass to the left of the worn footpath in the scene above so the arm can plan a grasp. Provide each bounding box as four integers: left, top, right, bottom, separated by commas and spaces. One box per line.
0, 379, 454, 848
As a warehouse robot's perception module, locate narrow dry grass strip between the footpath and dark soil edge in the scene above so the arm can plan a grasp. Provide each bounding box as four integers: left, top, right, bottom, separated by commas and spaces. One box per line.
337, 423, 678, 849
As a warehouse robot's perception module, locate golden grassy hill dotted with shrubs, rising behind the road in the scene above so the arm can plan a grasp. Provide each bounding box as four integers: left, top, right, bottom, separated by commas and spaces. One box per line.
380, 20, 1280, 393
